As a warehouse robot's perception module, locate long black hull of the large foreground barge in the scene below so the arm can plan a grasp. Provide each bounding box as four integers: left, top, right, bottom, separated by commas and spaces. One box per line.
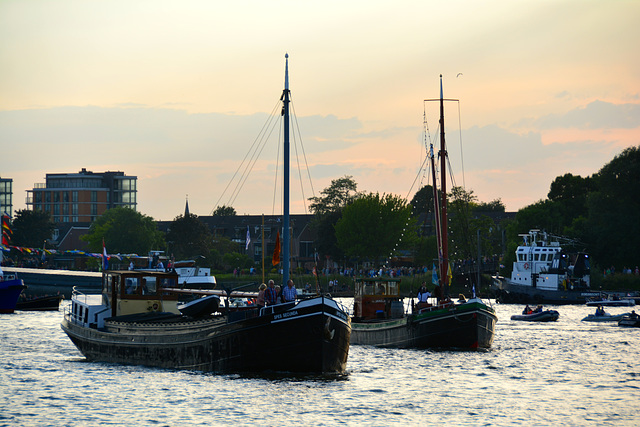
62, 297, 351, 373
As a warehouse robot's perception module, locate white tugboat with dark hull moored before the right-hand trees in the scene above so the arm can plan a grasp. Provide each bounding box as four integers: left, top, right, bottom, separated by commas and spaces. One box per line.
493, 230, 597, 305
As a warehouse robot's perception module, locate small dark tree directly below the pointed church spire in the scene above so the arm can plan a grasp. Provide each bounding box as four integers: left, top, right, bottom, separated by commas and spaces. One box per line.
166, 214, 212, 259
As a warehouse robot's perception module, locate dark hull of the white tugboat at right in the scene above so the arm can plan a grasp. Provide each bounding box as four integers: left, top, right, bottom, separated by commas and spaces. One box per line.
495, 280, 598, 305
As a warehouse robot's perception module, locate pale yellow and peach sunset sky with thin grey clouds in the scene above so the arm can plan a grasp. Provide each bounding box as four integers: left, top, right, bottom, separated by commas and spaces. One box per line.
0, 0, 640, 220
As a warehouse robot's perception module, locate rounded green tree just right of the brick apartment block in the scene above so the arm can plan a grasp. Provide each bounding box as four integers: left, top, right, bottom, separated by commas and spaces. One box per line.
82, 207, 164, 255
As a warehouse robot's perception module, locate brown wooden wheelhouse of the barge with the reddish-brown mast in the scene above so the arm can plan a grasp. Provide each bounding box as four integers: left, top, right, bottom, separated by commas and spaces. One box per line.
353, 277, 404, 321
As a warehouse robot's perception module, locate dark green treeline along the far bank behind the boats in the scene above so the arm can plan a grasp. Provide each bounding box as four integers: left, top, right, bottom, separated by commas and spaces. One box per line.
6, 147, 640, 271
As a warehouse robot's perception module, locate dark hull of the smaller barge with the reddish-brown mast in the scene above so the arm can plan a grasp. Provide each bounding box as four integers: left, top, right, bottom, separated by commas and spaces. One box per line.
351, 303, 498, 349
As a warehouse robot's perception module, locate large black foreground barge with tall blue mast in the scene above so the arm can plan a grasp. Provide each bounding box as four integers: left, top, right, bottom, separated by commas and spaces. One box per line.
61, 55, 351, 373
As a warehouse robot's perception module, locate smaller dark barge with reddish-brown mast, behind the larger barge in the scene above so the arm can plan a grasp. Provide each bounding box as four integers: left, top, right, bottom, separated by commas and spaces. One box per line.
351, 76, 498, 349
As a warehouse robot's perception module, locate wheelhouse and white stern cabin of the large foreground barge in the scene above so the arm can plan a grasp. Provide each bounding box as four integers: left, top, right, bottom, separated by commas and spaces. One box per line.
69, 270, 180, 328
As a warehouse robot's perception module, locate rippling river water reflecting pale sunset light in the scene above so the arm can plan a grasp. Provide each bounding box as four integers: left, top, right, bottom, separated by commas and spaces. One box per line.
0, 305, 640, 426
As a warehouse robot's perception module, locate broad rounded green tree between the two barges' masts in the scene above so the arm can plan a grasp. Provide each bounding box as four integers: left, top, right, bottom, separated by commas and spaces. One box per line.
335, 193, 415, 261
